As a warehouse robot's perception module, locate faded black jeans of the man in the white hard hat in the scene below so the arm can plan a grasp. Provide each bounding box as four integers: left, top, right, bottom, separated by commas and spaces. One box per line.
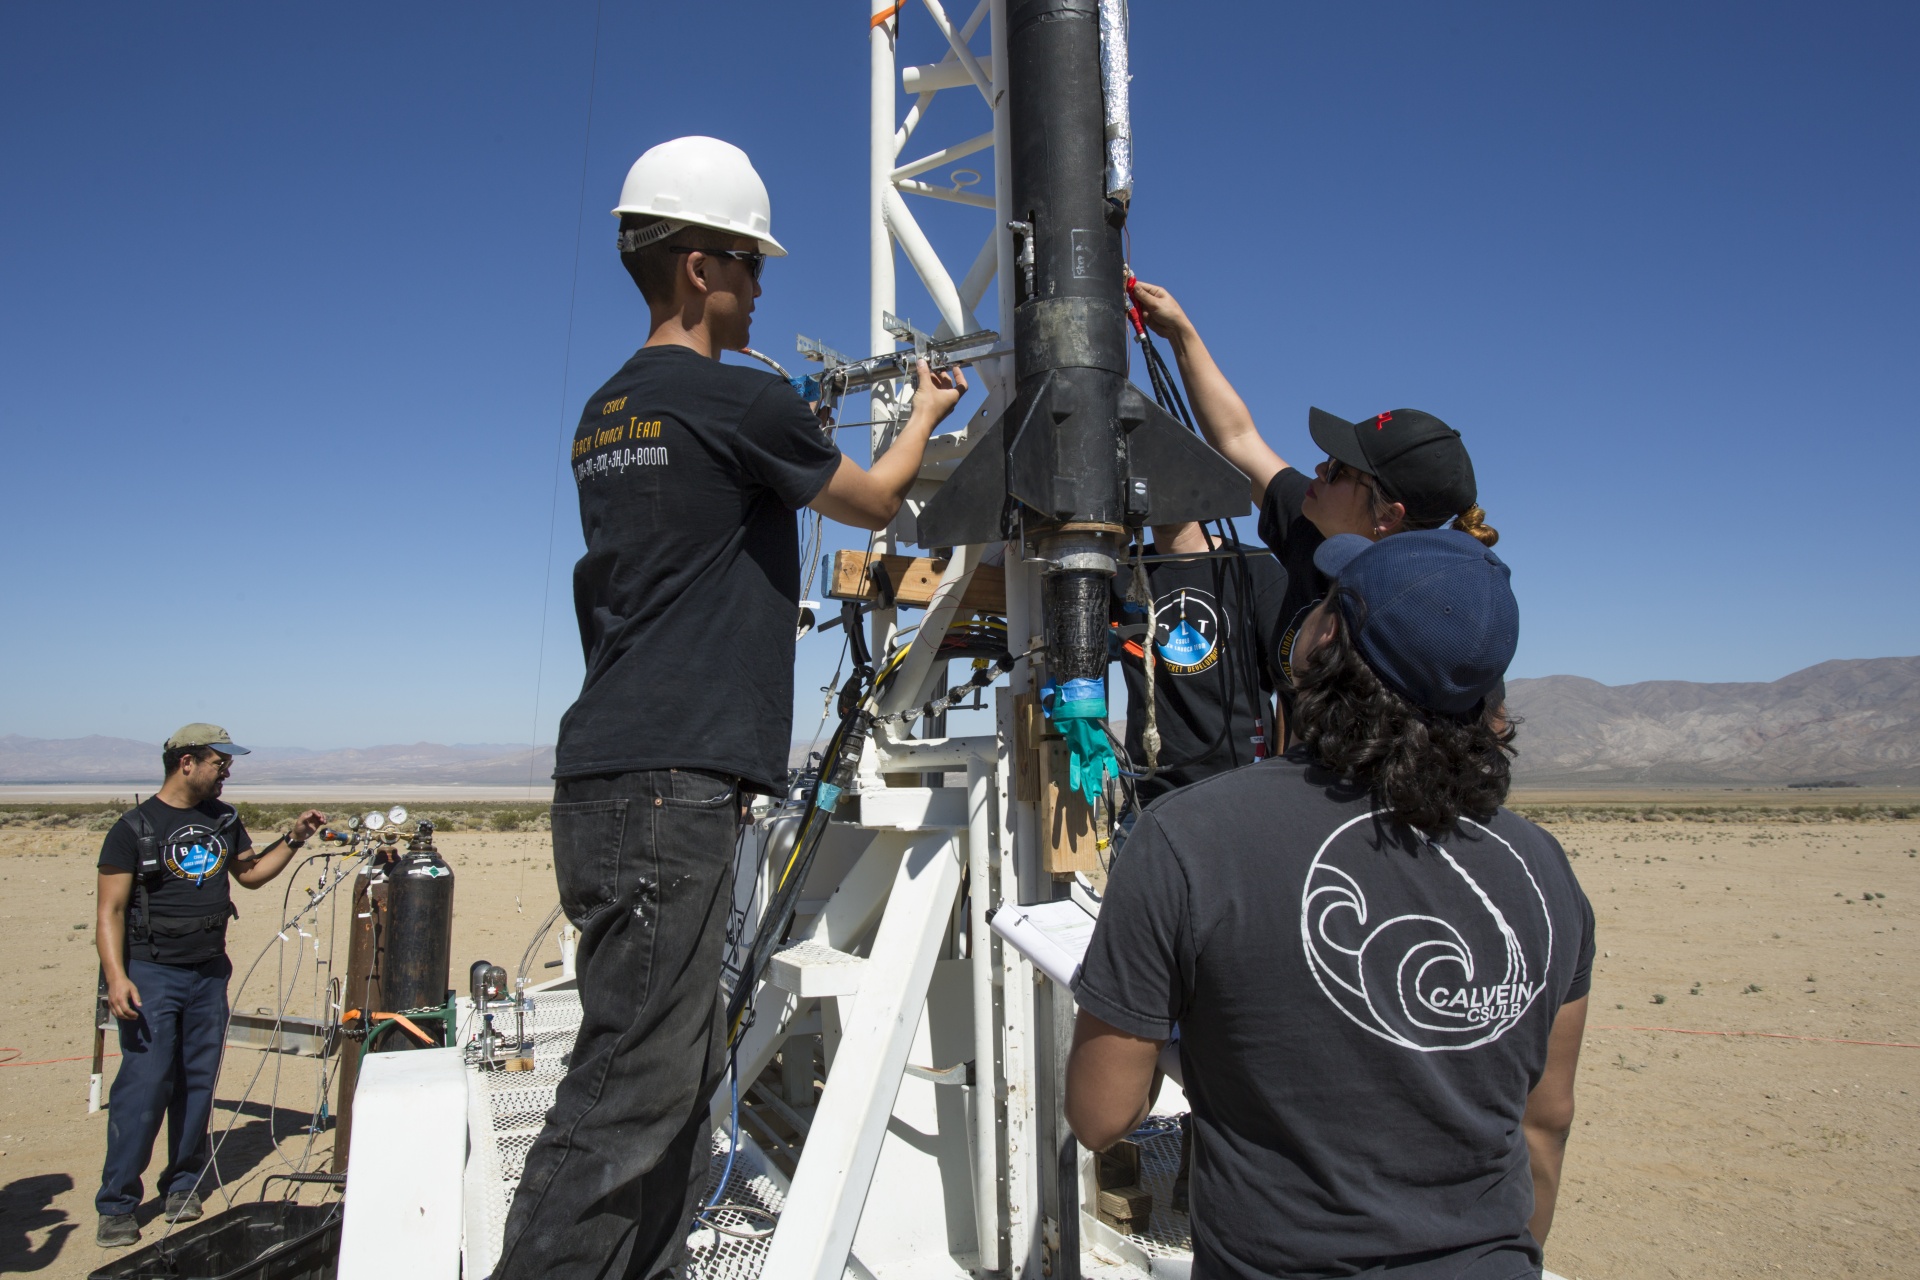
493, 770, 739, 1280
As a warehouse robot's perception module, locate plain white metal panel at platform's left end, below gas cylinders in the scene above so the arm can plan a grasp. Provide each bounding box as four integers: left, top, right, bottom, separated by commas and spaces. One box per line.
338, 1048, 467, 1280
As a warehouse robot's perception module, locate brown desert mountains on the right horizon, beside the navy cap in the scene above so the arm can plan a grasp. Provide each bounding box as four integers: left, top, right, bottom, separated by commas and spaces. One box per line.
1507, 658, 1920, 787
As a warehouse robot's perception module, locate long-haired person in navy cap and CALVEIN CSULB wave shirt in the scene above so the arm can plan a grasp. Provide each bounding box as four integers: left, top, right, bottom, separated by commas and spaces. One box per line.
1066, 530, 1594, 1280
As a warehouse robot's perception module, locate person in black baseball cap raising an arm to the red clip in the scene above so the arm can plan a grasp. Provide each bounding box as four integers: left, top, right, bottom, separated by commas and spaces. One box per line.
1135, 282, 1500, 741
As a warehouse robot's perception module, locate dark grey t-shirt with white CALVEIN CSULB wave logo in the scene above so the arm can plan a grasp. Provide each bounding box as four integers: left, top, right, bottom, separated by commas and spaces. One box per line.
1075, 750, 1594, 1280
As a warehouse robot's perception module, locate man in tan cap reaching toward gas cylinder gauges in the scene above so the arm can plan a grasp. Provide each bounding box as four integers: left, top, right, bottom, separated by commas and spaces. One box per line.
94, 723, 326, 1245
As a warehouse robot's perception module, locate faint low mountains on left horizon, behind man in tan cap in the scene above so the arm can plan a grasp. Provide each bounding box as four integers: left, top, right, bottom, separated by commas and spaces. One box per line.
0, 733, 553, 787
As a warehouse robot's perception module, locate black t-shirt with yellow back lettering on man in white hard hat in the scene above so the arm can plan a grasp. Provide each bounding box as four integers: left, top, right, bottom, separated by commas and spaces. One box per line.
553, 345, 839, 793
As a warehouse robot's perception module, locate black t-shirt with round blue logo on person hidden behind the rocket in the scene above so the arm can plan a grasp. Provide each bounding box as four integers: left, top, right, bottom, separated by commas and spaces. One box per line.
1112, 549, 1286, 804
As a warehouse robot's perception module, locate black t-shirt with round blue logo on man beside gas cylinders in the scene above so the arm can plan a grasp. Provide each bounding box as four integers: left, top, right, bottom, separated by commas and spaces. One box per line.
98, 796, 253, 960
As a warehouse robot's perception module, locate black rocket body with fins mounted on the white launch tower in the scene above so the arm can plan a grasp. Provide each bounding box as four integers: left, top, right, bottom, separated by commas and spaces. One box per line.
918, 0, 1248, 683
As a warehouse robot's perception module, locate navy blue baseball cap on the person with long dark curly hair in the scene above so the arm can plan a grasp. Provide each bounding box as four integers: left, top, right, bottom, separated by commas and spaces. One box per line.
1313, 530, 1521, 716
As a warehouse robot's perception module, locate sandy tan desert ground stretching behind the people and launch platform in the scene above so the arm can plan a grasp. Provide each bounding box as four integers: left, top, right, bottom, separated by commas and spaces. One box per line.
0, 796, 1920, 1280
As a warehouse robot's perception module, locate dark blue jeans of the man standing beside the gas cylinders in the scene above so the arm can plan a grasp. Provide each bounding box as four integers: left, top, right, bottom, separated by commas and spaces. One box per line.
94, 956, 232, 1215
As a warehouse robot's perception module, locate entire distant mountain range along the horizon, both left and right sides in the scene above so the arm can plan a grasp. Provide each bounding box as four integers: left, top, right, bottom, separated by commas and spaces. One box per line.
0, 658, 1920, 787
